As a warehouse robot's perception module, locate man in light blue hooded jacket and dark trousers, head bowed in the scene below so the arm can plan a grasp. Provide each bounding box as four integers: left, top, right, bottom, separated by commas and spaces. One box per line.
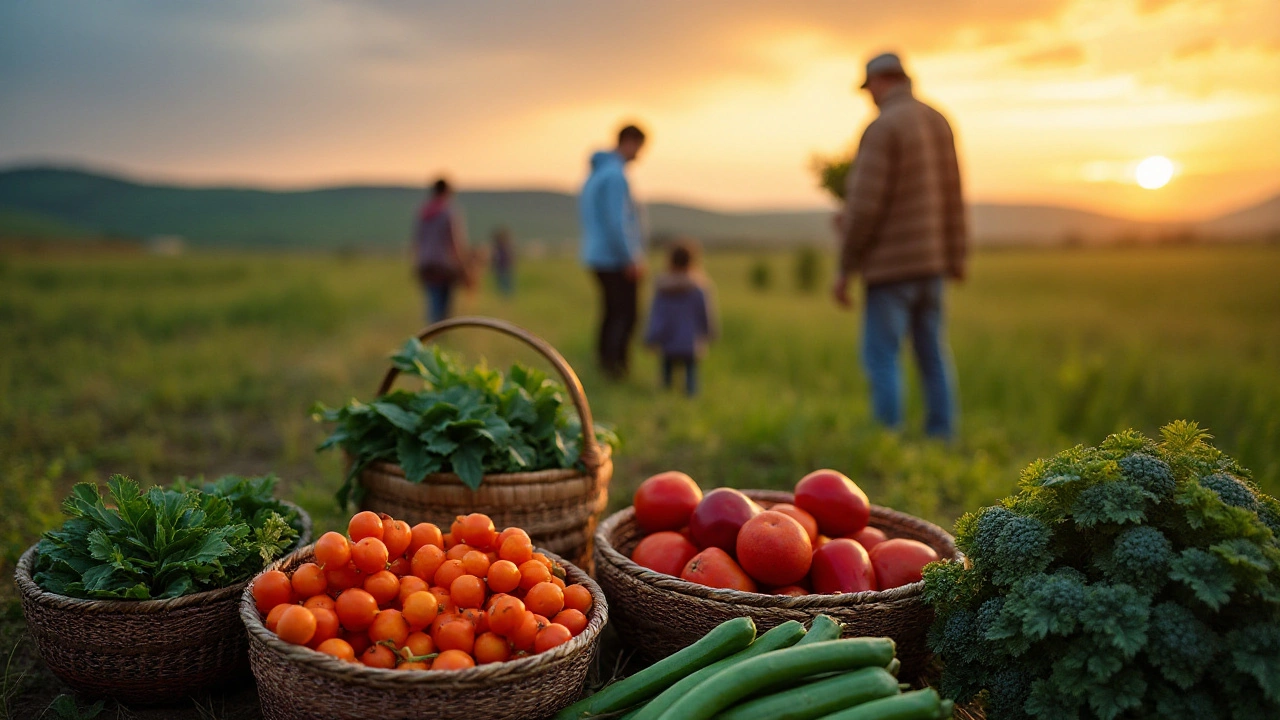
579, 126, 645, 379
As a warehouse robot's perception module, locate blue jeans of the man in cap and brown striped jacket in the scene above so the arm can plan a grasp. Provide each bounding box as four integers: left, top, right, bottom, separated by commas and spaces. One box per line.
863, 275, 955, 438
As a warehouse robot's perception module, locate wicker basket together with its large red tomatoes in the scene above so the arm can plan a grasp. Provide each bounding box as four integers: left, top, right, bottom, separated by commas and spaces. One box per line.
595, 470, 960, 676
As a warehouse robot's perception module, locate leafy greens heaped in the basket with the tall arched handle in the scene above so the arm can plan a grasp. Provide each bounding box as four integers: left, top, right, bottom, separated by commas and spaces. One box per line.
314, 338, 617, 503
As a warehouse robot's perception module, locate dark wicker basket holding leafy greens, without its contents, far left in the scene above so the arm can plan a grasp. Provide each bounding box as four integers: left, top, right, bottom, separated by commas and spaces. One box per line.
15, 506, 311, 705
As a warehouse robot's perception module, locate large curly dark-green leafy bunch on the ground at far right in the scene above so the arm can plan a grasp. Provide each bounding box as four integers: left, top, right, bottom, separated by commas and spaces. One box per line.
924, 421, 1280, 720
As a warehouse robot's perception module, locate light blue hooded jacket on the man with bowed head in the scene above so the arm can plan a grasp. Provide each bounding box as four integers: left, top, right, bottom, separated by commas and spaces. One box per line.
579, 150, 643, 270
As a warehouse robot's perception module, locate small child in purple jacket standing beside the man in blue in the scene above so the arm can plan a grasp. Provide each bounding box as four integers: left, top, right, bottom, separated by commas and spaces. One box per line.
644, 242, 716, 397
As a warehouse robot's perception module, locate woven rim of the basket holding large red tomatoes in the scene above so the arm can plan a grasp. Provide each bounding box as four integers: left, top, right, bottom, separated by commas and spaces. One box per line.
595, 489, 964, 610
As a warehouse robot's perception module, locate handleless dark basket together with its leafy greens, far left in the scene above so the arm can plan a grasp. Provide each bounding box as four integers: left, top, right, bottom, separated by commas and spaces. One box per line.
17, 475, 311, 703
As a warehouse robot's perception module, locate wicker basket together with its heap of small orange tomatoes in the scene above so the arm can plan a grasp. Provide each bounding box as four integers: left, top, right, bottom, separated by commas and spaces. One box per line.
241, 511, 608, 720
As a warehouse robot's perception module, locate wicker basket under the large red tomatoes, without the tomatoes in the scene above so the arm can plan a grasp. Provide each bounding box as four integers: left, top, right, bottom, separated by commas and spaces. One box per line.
595, 491, 960, 679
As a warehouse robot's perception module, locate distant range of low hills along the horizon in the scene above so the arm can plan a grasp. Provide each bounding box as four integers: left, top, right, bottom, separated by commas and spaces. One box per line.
0, 168, 1280, 250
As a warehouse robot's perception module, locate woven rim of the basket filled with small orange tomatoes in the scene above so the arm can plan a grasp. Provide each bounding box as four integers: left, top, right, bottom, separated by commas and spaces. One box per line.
239, 544, 609, 688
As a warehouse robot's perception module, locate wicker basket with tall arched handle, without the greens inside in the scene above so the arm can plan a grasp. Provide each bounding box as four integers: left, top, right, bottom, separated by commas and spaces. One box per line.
350, 318, 613, 569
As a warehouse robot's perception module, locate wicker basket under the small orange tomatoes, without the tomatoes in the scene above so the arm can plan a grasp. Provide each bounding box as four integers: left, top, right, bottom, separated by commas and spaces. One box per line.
239, 547, 609, 720
